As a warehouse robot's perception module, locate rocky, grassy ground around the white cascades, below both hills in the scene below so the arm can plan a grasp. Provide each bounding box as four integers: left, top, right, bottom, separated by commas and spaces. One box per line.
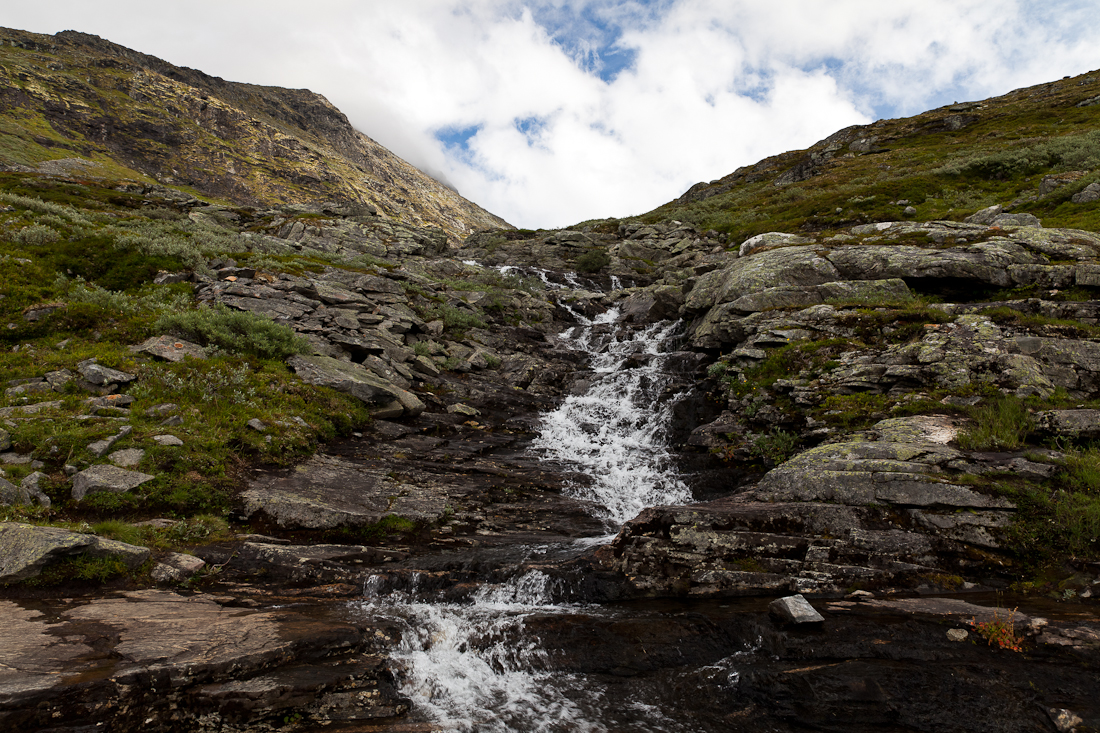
0, 34, 1100, 732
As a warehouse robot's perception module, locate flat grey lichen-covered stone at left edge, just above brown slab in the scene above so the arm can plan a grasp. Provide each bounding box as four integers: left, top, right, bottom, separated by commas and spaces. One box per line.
0, 522, 150, 583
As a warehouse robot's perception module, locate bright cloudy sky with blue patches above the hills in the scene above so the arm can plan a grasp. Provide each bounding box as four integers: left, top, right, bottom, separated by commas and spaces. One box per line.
0, 0, 1100, 228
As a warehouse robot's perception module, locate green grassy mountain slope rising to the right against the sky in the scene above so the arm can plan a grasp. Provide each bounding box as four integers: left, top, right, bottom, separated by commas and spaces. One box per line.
641, 72, 1100, 243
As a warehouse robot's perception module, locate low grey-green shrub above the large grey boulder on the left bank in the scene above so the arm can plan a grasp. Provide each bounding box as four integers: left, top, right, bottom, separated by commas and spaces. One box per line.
155, 305, 311, 359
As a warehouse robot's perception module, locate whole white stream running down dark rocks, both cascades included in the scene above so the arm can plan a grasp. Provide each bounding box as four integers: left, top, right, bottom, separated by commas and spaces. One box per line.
352, 294, 712, 733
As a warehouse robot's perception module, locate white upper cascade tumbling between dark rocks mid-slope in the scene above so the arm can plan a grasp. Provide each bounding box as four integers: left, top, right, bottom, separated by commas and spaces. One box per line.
532, 309, 692, 526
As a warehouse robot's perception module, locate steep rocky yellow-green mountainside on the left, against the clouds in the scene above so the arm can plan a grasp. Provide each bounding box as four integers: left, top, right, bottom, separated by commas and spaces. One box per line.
0, 29, 508, 242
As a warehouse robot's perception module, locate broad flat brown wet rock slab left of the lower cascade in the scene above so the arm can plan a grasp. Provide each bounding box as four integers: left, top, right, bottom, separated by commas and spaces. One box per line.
0, 590, 404, 732
